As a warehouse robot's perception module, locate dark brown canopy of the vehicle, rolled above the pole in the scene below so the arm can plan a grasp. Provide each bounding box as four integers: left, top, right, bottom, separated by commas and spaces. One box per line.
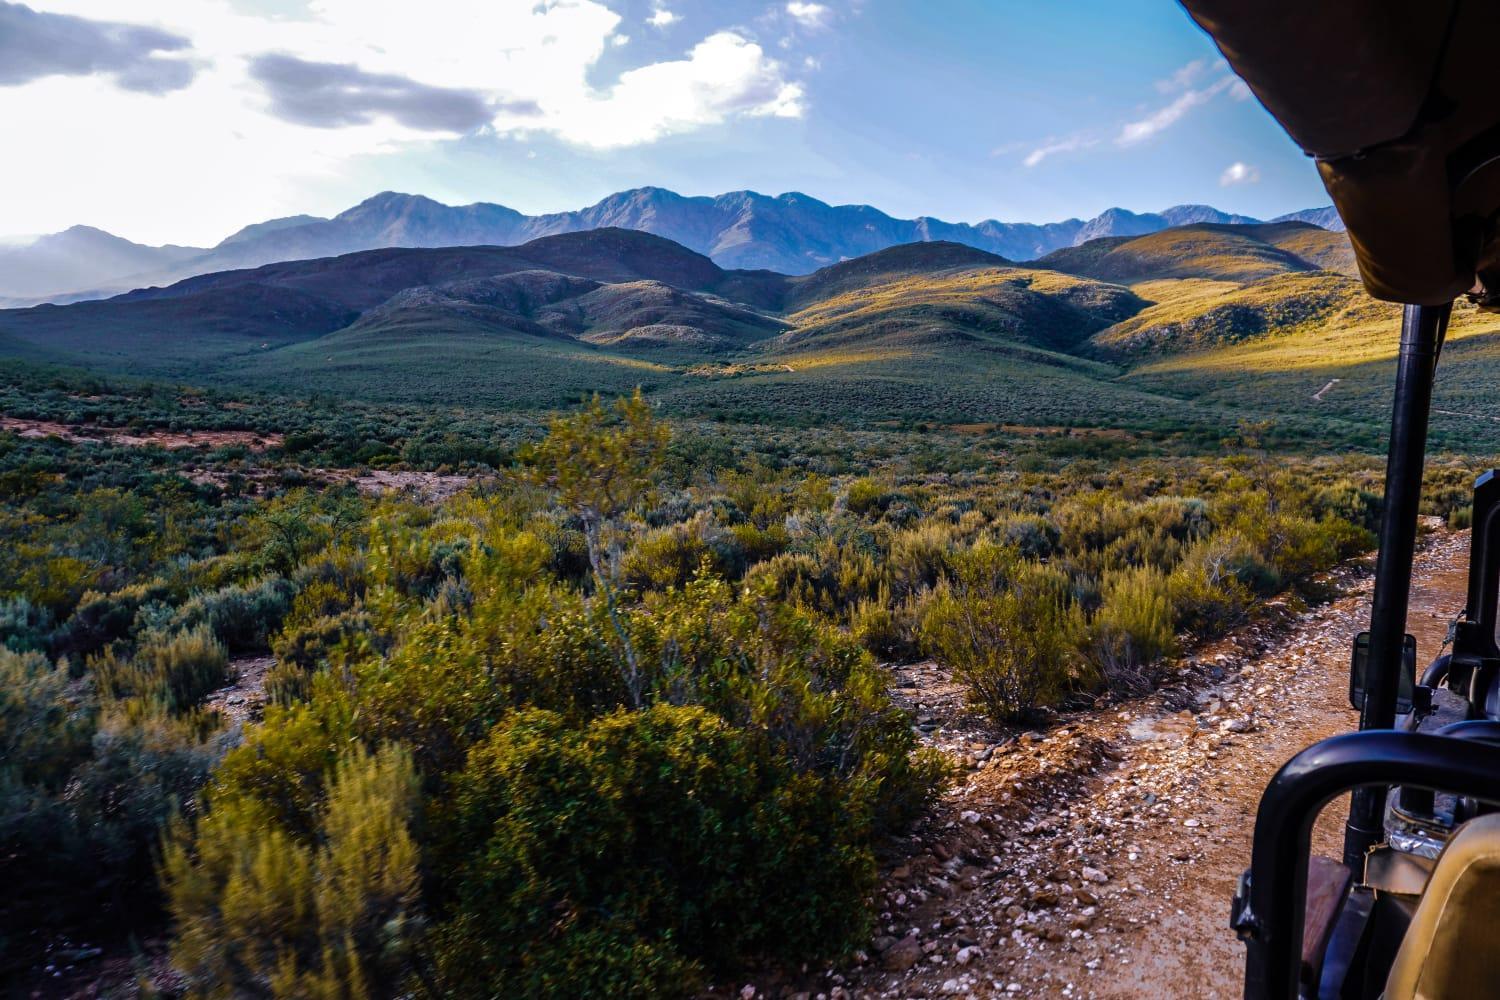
1182, 0, 1500, 306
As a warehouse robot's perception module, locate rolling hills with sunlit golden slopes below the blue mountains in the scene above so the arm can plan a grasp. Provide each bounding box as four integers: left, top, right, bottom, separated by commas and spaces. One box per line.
0, 222, 1500, 444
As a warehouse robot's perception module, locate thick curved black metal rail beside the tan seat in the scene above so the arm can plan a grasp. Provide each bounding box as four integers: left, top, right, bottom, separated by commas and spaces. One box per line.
1235, 729, 1500, 1000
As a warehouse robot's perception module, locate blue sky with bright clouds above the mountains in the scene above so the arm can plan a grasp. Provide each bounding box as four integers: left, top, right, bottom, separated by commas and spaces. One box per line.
0, 0, 1328, 246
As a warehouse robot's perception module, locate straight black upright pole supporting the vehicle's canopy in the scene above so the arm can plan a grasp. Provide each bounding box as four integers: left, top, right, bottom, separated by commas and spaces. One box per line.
1344, 303, 1452, 871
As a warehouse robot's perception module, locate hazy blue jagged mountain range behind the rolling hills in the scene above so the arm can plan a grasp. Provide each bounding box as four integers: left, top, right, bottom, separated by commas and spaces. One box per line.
0, 187, 1343, 306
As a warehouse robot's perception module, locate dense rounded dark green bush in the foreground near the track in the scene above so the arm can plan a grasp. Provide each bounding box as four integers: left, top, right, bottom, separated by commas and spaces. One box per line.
440, 705, 875, 997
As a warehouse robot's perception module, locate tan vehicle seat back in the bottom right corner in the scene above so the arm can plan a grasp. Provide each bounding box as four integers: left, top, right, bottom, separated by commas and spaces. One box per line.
1385, 813, 1500, 1000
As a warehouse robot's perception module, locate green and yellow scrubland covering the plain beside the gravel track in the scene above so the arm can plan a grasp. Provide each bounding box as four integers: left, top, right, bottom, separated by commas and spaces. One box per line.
0, 361, 1472, 997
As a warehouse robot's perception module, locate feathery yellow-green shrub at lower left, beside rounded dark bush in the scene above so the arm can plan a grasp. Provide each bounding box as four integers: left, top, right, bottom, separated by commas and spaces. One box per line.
162, 747, 423, 1000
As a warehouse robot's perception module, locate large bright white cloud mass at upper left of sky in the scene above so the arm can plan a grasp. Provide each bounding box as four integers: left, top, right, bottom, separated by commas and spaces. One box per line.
0, 0, 806, 243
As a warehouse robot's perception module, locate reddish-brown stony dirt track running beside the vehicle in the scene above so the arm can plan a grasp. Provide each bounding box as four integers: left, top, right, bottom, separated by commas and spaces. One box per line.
719, 531, 1469, 1000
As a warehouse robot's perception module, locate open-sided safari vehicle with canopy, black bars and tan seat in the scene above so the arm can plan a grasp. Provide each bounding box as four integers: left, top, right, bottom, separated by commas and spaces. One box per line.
1182, 0, 1500, 1000
